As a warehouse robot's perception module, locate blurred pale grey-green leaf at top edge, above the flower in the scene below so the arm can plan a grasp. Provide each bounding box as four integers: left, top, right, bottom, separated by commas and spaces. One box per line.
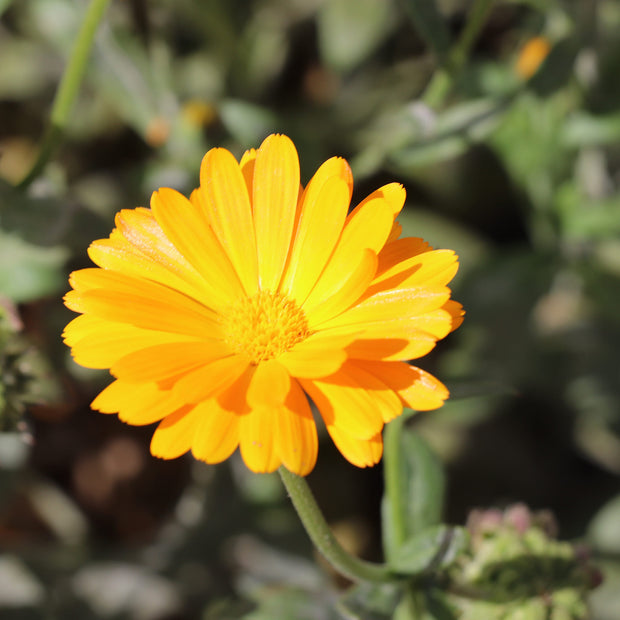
317, 0, 394, 71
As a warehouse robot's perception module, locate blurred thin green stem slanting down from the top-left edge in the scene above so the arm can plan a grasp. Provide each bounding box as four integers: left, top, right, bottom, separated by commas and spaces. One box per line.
18, 0, 110, 189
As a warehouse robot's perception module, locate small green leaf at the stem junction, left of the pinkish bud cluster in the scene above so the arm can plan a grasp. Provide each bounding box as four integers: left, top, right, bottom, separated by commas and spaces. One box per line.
390, 525, 469, 576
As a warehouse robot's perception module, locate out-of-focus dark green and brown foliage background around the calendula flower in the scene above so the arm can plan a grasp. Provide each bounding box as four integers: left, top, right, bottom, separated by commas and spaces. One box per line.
0, 0, 620, 620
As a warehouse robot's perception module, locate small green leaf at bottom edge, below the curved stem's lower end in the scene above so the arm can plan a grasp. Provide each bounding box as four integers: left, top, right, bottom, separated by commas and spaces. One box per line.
337, 583, 402, 620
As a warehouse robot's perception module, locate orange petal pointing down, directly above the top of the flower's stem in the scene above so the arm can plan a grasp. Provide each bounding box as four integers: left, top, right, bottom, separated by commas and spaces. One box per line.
275, 380, 318, 476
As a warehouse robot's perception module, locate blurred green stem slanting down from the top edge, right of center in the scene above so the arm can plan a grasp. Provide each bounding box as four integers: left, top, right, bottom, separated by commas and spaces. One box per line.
422, 0, 493, 108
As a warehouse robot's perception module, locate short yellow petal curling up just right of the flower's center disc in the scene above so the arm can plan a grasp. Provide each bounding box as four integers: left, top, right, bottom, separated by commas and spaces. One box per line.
303, 250, 377, 330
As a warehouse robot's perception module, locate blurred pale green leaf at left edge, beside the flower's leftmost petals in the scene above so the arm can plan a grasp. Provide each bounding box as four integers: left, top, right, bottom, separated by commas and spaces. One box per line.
0, 231, 68, 303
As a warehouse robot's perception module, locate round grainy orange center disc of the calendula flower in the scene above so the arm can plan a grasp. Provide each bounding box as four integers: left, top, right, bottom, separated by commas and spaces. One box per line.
224, 291, 310, 364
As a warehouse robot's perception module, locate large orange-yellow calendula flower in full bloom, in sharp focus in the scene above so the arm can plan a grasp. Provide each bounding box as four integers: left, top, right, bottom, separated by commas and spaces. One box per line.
64, 135, 462, 475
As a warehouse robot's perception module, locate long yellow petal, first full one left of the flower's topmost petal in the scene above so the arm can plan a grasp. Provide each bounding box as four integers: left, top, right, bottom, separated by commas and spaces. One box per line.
200, 149, 258, 296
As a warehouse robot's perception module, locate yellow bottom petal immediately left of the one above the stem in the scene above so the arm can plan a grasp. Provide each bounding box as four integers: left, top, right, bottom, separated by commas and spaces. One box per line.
239, 407, 282, 474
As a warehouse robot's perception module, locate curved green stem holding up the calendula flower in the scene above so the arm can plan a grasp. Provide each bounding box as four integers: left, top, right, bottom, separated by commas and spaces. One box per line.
278, 467, 394, 582
